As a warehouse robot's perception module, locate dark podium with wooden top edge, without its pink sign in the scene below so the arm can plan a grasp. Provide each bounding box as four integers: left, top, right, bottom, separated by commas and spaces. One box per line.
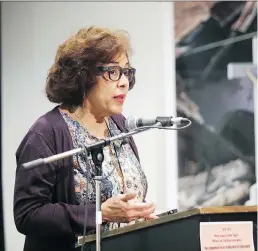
78, 206, 257, 251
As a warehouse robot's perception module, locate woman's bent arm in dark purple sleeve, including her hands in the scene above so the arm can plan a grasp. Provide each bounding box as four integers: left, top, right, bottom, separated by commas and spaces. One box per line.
14, 128, 155, 237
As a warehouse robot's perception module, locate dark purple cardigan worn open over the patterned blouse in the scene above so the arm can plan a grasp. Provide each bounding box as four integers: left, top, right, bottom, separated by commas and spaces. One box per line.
14, 107, 139, 251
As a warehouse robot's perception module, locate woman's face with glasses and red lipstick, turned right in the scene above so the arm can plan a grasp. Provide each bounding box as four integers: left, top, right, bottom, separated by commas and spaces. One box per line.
87, 54, 135, 117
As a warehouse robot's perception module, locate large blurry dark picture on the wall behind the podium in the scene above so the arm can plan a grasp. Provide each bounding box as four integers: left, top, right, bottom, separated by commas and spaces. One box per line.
174, 1, 257, 210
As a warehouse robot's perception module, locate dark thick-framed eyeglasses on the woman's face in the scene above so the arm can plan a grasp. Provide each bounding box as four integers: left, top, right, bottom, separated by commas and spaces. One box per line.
97, 66, 136, 83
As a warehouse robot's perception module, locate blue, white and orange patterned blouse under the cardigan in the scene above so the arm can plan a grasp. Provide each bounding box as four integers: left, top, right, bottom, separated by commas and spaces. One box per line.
60, 111, 147, 230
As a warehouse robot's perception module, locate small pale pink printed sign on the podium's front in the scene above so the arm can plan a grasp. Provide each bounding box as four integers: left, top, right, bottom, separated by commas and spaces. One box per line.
200, 221, 254, 251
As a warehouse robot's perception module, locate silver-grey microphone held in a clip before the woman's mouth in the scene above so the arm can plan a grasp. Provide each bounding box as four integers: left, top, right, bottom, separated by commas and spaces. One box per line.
125, 116, 189, 131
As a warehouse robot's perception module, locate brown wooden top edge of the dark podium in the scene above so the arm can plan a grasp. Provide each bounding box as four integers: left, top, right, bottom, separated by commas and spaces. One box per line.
78, 206, 258, 245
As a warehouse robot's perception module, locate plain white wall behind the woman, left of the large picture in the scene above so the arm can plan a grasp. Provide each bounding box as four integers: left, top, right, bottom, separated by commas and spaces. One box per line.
2, 2, 177, 251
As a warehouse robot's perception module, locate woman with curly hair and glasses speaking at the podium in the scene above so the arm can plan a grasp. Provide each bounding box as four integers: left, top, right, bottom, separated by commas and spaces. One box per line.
14, 27, 156, 251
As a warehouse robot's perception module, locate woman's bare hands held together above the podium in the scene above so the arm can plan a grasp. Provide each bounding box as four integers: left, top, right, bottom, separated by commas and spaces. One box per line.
101, 193, 156, 223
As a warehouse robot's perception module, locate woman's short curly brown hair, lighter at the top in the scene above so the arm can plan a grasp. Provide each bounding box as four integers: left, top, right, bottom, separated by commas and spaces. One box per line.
46, 27, 135, 110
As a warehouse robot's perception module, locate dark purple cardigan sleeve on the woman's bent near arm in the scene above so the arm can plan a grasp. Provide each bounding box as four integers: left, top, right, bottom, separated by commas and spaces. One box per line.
13, 131, 96, 237
